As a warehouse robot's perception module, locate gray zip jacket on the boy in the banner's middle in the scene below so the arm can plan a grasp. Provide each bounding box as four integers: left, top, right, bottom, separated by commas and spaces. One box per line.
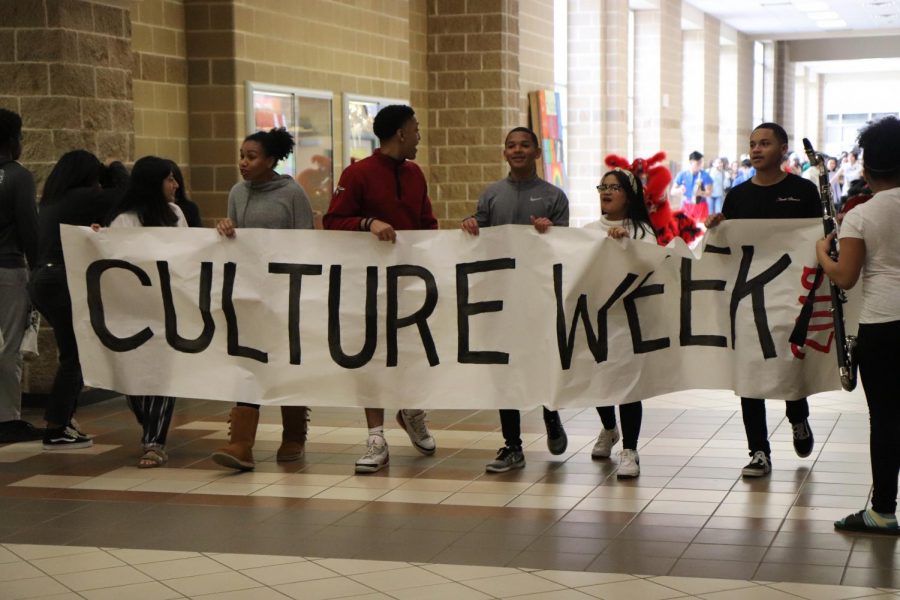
472, 176, 569, 227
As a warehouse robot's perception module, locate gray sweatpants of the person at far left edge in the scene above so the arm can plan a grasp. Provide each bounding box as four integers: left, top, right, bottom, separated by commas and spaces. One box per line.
0, 267, 31, 423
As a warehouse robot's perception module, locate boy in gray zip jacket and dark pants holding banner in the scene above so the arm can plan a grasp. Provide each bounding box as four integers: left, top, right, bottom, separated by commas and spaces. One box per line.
462, 127, 569, 473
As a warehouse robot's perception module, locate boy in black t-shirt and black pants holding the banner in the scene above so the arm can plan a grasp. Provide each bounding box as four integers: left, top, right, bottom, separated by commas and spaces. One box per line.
706, 123, 822, 477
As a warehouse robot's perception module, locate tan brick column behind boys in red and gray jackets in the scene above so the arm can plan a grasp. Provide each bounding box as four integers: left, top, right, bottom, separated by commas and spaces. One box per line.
426, 0, 519, 228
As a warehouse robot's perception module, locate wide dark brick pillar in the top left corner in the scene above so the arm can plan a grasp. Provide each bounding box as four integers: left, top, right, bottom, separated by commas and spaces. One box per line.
0, 0, 133, 188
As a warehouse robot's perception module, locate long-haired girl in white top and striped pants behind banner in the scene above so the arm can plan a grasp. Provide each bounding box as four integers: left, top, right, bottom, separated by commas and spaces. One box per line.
109, 156, 187, 469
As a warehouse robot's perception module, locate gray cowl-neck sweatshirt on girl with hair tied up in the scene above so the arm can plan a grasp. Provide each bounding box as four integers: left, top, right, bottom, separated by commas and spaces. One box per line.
228, 175, 313, 229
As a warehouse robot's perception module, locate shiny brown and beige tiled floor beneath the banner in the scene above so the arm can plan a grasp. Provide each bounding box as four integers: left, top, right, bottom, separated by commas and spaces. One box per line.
0, 390, 900, 600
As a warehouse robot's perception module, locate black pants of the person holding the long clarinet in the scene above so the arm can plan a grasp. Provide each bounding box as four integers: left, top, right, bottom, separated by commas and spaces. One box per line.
857, 321, 900, 513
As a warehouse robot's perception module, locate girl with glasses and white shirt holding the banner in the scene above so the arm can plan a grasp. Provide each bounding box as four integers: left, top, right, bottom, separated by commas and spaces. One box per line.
585, 167, 656, 479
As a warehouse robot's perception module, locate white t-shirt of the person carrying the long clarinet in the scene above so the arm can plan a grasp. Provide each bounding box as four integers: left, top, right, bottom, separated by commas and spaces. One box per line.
840, 188, 900, 323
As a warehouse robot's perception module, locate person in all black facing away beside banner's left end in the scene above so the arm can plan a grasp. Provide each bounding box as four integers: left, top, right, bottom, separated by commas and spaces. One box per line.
29, 150, 127, 450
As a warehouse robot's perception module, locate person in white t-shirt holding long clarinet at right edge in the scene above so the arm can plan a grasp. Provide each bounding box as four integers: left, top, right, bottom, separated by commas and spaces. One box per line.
816, 117, 900, 535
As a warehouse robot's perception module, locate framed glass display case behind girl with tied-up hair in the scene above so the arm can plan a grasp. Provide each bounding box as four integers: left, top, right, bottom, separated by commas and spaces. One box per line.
246, 82, 334, 212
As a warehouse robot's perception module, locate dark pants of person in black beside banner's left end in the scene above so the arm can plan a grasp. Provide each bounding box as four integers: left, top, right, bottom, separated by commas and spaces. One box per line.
28, 265, 84, 427
